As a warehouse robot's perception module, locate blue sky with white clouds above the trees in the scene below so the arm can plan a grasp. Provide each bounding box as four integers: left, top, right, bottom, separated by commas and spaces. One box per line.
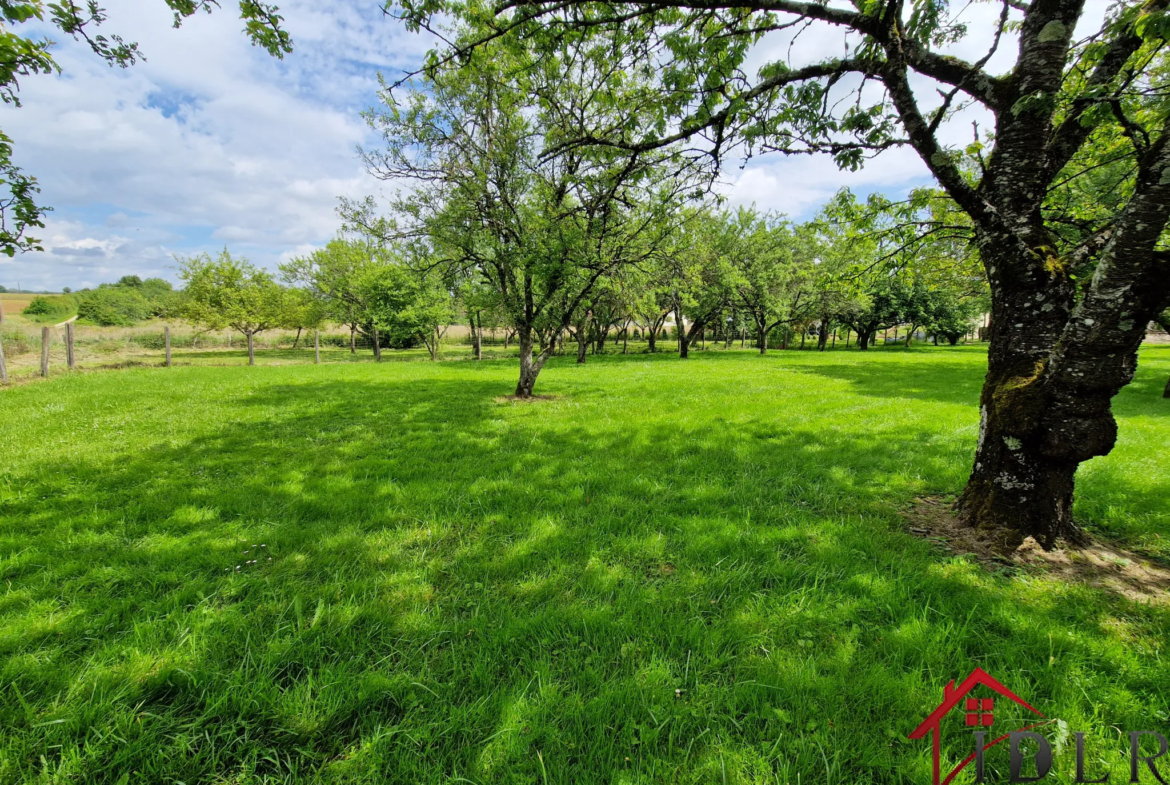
0, 0, 1095, 290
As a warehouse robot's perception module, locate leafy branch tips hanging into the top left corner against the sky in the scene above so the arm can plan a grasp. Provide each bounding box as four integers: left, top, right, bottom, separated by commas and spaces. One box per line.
0, 0, 293, 256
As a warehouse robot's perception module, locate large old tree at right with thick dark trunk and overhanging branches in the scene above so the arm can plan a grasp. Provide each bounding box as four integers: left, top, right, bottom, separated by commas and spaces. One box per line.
397, 0, 1170, 548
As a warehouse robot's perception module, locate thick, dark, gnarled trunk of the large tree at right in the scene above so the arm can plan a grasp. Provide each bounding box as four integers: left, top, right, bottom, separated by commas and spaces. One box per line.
958, 226, 1166, 548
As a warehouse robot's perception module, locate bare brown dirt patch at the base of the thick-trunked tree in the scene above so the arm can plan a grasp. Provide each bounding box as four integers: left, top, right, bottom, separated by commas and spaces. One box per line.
902, 496, 1170, 604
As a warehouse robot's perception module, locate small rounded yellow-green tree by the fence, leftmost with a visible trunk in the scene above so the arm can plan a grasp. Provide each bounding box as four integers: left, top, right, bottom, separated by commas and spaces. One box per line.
177, 248, 288, 365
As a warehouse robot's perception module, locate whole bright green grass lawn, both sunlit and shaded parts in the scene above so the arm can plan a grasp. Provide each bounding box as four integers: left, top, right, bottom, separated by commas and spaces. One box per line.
0, 347, 1170, 784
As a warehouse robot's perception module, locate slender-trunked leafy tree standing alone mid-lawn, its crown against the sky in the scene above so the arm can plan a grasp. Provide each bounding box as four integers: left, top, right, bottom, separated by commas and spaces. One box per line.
349, 33, 686, 398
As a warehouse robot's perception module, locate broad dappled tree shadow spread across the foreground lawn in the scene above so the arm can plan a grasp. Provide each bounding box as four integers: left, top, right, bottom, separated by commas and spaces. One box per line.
0, 376, 1170, 783
